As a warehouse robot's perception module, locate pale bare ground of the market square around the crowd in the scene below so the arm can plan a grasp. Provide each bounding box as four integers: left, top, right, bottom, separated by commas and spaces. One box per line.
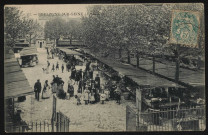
15, 48, 135, 131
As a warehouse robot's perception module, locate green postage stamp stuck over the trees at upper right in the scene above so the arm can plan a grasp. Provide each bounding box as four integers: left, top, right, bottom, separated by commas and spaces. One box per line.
170, 10, 200, 47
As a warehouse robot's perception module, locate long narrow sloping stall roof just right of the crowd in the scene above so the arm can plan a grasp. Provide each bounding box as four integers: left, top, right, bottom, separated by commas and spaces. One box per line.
80, 49, 183, 87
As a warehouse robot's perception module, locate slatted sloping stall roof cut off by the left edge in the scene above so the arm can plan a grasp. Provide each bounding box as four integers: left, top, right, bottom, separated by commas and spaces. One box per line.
4, 49, 33, 99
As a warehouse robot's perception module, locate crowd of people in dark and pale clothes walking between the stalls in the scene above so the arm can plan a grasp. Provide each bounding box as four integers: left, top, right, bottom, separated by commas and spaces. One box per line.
34, 49, 121, 105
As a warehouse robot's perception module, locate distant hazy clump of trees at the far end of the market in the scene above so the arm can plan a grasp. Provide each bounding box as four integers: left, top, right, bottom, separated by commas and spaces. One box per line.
44, 17, 81, 44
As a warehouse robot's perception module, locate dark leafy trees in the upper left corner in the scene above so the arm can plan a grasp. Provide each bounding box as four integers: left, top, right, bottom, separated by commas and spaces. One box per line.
4, 7, 41, 47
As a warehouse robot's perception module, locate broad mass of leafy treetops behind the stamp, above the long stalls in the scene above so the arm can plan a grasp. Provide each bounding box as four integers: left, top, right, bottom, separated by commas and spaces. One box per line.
82, 4, 204, 57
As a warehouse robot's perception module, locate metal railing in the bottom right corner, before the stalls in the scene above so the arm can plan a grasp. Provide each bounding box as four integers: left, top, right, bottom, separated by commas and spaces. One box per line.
137, 106, 206, 131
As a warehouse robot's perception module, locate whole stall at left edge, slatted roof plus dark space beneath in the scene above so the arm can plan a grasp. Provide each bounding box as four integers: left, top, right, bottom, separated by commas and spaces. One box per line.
4, 49, 34, 131
